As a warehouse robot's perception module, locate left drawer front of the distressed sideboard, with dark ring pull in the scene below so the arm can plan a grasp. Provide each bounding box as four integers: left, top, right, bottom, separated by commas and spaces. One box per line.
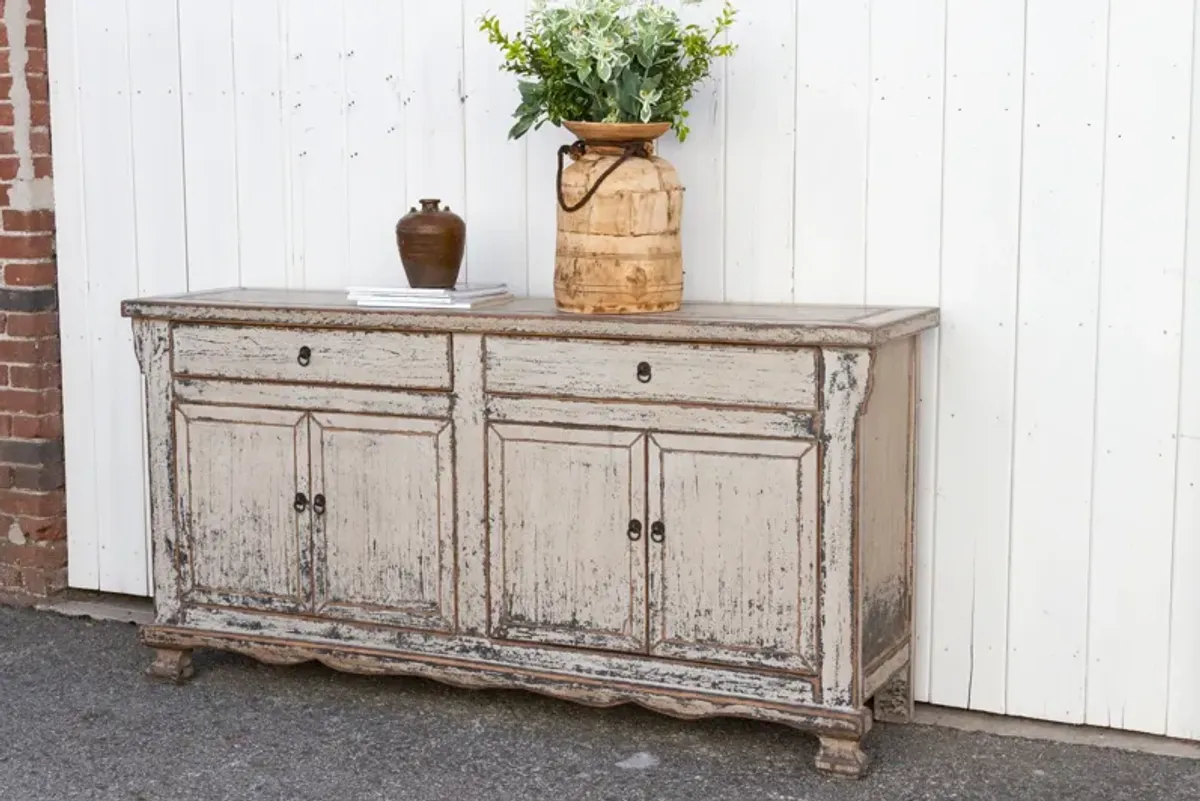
174, 325, 450, 390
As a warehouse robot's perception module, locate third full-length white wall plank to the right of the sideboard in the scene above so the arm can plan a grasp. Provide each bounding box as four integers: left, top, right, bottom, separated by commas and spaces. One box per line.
1086, 0, 1200, 729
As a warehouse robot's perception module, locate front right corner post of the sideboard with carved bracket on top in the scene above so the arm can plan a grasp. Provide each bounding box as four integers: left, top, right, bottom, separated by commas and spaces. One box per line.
820, 348, 872, 709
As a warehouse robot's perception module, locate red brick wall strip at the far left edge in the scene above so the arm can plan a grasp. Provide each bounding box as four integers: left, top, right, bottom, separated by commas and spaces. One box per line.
0, 0, 67, 596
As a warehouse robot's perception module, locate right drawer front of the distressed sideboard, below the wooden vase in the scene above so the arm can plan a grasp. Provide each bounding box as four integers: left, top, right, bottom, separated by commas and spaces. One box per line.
486, 337, 817, 409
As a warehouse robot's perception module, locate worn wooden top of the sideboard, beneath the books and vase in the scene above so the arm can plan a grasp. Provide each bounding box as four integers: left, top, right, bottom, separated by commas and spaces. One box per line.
121, 289, 938, 347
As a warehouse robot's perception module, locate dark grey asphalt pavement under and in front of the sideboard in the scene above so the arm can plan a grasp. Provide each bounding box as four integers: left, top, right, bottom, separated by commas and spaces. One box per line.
0, 607, 1200, 801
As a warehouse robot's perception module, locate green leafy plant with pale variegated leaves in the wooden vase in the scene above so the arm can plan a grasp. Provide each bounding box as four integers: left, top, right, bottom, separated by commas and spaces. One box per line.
480, 0, 737, 141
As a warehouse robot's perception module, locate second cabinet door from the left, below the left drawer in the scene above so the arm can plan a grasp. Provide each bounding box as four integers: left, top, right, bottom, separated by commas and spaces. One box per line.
312, 412, 455, 630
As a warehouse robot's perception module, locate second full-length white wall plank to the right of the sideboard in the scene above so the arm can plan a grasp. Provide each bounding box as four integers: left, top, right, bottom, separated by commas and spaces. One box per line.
1006, 0, 1109, 723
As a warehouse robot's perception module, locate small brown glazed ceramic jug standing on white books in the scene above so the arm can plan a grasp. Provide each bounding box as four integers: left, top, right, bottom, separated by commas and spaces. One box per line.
396, 199, 467, 289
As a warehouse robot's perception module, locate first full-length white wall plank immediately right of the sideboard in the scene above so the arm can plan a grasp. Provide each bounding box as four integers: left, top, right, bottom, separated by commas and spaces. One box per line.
929, 0, 1022, 712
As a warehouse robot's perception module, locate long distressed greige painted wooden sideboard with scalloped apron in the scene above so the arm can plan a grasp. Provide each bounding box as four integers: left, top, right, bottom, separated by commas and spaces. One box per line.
122, 289, 938, 776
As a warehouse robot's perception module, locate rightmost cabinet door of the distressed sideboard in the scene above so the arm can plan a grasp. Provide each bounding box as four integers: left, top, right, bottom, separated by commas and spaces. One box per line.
649, 434, 820, 673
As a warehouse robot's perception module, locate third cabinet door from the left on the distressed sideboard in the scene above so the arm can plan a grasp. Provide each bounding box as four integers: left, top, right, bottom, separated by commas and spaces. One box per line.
487, 424, 646, 651
